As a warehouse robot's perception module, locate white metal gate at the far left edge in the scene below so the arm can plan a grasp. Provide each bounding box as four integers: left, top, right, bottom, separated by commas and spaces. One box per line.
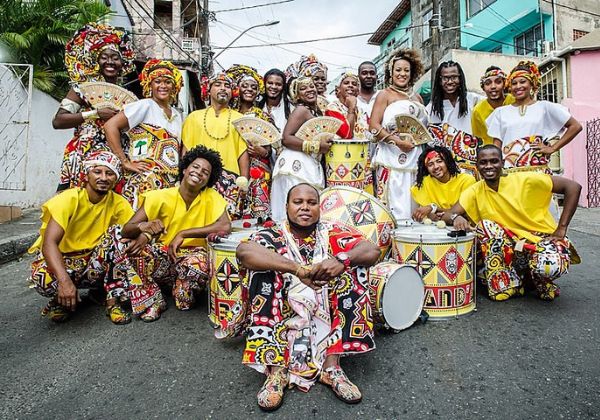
0, 63, 33, 190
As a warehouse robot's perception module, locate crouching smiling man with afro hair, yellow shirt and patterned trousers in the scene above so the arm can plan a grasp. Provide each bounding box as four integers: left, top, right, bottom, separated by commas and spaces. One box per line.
119, 145, 231, 322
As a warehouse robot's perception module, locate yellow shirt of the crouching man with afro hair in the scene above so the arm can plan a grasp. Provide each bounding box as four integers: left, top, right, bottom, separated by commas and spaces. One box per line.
141, 187, 227, 247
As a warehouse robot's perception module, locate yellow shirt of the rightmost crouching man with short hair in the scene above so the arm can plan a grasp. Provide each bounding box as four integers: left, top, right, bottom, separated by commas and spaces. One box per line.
459, 172, 557, 243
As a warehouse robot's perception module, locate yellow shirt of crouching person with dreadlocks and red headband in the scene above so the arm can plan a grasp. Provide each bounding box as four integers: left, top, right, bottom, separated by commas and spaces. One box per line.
410, 174, 476, 209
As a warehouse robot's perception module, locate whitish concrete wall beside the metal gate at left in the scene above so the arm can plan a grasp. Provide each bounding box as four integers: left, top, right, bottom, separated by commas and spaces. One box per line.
0, 88, 73, 208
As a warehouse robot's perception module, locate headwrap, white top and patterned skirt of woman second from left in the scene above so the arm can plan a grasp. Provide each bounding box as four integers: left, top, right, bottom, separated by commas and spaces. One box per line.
118, 59, 183, 210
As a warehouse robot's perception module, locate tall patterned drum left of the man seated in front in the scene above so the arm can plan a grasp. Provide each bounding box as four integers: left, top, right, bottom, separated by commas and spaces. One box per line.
208, 230, 256, 338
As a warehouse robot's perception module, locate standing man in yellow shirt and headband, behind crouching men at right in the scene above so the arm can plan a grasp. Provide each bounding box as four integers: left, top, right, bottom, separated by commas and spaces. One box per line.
471, 66, 515, 144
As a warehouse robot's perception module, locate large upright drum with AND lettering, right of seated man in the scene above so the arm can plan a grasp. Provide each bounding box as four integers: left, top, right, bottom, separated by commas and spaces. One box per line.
392, 224, 476, 320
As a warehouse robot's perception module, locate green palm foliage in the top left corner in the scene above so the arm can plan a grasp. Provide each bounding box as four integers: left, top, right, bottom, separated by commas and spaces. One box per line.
0, 0, 111, 100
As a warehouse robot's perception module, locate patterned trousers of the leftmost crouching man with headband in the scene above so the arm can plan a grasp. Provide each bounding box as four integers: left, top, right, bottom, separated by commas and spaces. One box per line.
29, 228, 128, 300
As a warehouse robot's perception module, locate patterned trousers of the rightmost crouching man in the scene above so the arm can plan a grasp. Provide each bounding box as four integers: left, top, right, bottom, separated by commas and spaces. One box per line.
477, 220, 570, 300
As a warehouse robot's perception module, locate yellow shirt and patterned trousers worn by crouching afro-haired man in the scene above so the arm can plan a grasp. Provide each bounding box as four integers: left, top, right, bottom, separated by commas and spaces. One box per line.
113, 187, 226, 314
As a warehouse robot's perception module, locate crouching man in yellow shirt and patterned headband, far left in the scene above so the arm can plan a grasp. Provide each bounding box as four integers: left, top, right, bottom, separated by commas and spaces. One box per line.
29, 151, 133, 324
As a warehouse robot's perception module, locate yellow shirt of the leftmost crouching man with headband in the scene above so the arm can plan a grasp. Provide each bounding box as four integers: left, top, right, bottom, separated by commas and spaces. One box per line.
29, 188, 134, 254
